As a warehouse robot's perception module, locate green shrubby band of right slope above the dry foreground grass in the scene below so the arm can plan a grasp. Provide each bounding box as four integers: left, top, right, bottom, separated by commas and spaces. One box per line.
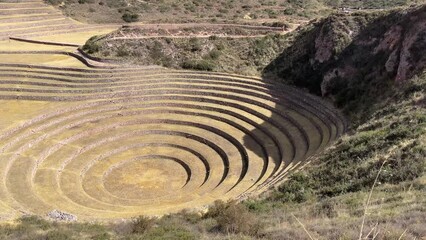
273, 73, 426, 201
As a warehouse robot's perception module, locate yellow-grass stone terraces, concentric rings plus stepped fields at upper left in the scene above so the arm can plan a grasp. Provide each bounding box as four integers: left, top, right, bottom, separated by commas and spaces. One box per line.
0, 1, 347, 220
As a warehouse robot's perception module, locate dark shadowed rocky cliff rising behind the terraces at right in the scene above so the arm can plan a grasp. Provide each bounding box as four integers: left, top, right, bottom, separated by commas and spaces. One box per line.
264, 5, 426, 115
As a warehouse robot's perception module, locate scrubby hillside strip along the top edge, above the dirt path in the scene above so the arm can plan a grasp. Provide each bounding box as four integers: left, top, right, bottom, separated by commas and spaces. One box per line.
46, 0, 425, 23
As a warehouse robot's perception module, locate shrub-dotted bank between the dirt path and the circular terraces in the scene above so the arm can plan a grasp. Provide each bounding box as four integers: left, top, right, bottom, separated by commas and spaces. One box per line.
83, 31, 289, 75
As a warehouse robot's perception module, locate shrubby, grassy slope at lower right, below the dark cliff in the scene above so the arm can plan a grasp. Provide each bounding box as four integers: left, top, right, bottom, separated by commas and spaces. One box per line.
255, 69, 426, 239
